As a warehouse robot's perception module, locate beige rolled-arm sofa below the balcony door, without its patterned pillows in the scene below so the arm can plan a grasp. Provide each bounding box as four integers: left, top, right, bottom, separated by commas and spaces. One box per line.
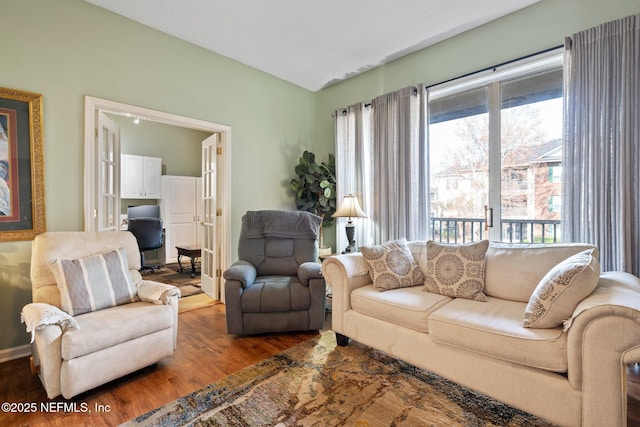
323, 242, 640, 427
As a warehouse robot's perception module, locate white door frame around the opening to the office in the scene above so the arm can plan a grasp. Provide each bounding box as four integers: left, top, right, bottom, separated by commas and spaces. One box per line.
84, 96, 231, 296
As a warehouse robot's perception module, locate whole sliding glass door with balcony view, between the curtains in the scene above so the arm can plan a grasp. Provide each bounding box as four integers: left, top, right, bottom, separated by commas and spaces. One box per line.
428, 51, 563, 242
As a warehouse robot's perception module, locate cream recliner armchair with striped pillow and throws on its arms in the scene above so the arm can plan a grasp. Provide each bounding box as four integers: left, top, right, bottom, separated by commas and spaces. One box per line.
22, 231, 180, 399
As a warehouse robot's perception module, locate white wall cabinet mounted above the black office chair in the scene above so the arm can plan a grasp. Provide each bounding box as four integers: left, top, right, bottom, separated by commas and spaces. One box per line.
120, 154, 162, 199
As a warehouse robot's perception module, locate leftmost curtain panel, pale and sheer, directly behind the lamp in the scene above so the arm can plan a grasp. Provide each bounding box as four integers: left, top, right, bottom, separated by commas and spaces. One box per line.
334, 102, 373, 253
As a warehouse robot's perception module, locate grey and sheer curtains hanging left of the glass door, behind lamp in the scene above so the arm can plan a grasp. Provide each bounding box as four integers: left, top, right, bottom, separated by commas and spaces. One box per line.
335, 86, 429, 247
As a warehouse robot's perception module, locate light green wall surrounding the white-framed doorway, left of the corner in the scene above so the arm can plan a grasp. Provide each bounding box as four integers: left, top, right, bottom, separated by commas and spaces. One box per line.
0, 0, 314, 350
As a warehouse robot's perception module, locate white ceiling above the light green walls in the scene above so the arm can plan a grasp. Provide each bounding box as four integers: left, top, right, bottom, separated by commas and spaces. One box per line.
86, 0, 540, 91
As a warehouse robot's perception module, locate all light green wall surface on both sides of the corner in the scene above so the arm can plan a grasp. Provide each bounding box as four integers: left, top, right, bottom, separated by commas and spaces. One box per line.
0, 0, 640, 349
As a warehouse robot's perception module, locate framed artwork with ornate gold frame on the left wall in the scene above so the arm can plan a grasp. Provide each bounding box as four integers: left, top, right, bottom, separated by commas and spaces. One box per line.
0, 87, 46, 242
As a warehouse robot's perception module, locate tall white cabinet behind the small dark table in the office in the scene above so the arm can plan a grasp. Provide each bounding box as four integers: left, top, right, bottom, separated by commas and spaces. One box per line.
160, 175, 203, 263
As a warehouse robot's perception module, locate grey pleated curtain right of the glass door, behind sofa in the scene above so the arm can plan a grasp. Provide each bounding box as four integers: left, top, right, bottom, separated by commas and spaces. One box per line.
562, 15, 640, 275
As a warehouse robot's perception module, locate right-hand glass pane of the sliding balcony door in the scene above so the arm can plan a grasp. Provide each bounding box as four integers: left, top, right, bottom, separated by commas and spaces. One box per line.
500, 70, 562, 243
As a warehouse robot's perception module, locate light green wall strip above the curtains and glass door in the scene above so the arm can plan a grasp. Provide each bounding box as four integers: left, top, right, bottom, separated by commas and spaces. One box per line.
315, 0, 640, 166
